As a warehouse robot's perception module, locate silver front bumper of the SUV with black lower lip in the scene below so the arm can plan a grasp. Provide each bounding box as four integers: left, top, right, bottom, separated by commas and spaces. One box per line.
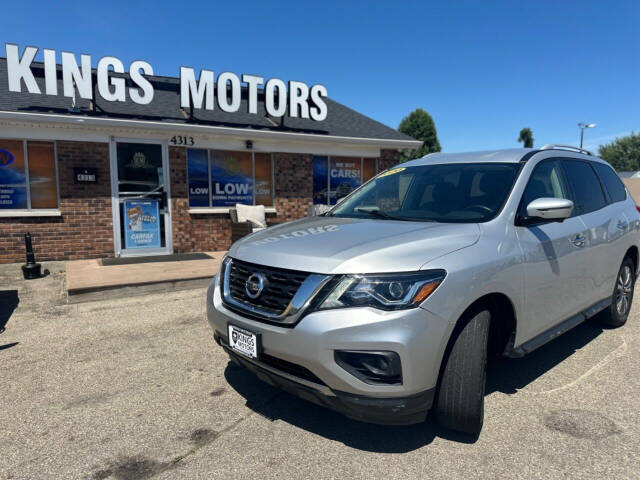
207, 280, 451, 424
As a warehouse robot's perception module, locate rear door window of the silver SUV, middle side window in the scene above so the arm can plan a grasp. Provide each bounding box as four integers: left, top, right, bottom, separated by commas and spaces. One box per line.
562, 160, 607, 215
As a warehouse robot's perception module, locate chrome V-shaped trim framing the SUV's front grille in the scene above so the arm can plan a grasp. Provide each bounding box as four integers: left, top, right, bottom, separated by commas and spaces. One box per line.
222, 257, 331, 325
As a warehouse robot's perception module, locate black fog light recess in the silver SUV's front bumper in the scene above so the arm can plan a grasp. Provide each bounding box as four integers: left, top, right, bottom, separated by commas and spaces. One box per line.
333, 350, 402, 385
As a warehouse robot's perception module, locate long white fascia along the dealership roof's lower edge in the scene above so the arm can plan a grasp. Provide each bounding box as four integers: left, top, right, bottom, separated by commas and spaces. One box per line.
0, 111, 422, 150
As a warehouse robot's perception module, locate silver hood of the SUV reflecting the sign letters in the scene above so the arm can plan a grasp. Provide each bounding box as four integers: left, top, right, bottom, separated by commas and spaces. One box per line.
229, 217, 480, 274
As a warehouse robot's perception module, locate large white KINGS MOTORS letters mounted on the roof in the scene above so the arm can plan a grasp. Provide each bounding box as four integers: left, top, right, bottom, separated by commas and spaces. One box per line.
6, 43, 327, 121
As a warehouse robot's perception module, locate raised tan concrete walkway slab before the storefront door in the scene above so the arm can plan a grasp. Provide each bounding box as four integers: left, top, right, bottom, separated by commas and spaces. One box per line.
66, 251, 226, 302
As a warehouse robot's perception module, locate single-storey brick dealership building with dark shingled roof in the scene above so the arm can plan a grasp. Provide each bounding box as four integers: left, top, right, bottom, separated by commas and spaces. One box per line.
0, 59, 420, 263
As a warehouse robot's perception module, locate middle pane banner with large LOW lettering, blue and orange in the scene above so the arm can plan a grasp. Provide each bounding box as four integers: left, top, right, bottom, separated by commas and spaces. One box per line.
211, 150, 253, 207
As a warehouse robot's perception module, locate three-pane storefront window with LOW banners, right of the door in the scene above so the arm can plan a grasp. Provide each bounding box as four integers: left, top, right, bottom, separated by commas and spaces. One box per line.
187, 149, 273, 208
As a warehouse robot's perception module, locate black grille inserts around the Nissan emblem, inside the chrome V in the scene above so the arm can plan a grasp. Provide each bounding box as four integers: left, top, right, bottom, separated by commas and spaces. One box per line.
227, 260, 309, 315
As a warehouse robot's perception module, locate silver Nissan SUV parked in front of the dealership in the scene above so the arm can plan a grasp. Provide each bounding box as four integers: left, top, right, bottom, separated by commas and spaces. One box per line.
207, 146, 640, 434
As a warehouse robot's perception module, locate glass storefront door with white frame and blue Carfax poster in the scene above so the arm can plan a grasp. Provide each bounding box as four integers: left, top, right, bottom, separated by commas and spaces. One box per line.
110, 139, 172, 256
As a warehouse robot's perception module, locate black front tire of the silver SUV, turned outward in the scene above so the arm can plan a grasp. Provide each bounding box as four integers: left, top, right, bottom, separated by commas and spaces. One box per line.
434, 308, 491, 435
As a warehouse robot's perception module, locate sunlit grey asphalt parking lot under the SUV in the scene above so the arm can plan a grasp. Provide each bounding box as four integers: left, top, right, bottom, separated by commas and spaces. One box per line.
0, 266, 640, 480
